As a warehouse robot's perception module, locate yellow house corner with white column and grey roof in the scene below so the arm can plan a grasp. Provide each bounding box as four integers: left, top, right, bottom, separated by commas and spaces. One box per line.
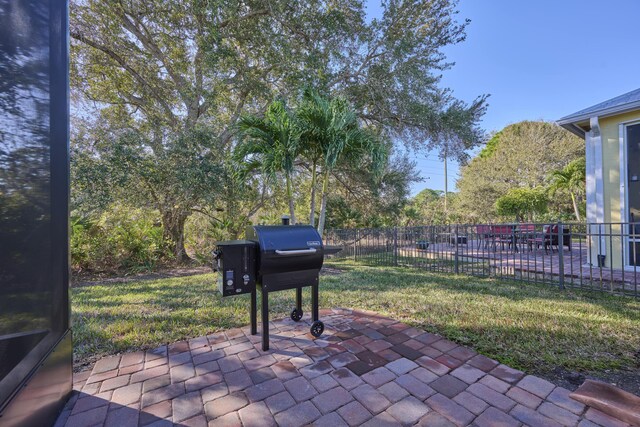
558, 89, 640, 268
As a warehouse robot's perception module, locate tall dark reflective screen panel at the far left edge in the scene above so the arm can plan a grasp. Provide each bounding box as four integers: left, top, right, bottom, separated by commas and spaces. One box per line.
0, 0, 68, 404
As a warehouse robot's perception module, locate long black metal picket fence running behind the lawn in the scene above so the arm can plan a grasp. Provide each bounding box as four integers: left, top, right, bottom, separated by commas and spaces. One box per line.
324, 222, 640, 298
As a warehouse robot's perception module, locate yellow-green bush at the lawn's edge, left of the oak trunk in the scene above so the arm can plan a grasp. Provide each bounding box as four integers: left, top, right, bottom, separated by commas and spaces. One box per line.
71, 205, 172, 272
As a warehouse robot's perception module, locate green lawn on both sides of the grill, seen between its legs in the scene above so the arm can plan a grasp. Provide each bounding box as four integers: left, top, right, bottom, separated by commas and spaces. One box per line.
71, 260, 640, 378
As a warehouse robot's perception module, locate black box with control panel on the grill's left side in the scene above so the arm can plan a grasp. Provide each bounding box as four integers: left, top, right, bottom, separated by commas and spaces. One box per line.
213, 240, 256, 297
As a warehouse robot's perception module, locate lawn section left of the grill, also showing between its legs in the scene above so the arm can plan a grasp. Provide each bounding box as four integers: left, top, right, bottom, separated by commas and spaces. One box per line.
71, 275, 310, 363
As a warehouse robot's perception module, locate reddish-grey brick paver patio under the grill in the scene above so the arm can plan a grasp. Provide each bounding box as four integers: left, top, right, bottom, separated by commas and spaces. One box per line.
57, 309, 626, 427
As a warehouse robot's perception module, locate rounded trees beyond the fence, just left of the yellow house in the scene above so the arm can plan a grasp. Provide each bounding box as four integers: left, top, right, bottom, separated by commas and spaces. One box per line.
404, 121, 585, 224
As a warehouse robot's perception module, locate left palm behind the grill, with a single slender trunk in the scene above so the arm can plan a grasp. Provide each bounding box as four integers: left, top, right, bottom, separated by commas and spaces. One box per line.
236, 101, 299, 224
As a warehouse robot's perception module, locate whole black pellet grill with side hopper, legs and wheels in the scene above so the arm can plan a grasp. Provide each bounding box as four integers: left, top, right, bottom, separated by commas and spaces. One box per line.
214, 225, 340, 351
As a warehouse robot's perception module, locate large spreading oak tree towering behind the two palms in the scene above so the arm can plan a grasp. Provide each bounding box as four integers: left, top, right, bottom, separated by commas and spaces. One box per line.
71, 0, 486, 260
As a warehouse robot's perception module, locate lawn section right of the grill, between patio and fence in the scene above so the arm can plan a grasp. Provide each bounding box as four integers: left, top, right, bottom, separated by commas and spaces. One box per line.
321, 267, 640, 371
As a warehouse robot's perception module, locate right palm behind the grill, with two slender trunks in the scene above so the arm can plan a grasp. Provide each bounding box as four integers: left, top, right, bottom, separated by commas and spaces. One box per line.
298, 90, 387, 235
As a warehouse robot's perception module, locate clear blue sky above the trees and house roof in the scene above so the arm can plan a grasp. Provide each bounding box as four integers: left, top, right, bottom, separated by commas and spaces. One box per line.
367, 0, 640, 194
